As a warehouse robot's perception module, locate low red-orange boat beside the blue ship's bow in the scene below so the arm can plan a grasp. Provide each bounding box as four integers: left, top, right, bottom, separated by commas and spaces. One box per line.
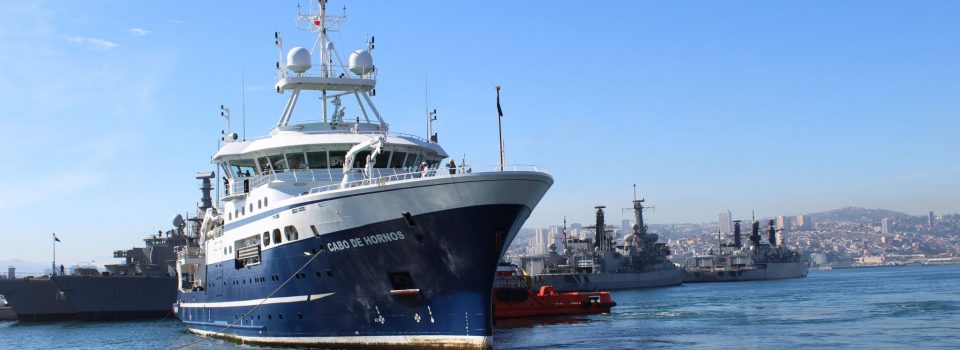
493, 263, 617, 320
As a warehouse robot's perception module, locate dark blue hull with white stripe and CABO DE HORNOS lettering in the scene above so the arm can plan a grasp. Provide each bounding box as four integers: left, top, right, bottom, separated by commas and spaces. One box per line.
178, 204, 531, 348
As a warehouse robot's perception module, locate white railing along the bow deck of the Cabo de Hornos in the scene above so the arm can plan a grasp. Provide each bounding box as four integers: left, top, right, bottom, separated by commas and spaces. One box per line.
305, 164, 546, 194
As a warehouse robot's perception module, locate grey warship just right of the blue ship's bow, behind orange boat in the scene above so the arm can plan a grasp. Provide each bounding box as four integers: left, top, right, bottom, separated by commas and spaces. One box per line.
522, 199, 683, 292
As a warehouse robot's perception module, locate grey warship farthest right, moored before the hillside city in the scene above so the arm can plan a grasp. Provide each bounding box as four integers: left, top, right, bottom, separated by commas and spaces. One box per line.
683, 220, 809, 283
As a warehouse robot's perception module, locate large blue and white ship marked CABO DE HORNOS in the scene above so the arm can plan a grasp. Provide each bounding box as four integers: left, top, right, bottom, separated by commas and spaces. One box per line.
174, 1, 553, 348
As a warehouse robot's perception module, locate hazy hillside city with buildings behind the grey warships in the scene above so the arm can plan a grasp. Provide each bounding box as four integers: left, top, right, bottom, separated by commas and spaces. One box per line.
507, 207, 960, 267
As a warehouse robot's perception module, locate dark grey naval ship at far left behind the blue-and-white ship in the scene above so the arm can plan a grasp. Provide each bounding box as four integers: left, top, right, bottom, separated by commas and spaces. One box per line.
0, 173, 213, 321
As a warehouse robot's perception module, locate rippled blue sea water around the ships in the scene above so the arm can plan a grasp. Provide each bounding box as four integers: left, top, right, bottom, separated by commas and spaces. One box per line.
0, 265, 960, 350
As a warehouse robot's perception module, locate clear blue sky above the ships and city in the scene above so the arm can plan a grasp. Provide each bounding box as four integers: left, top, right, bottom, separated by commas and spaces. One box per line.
0, 1, 960, 264
